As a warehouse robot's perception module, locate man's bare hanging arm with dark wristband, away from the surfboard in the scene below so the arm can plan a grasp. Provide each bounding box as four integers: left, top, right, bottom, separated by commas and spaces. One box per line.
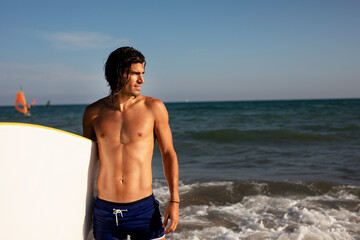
152, 100, 180, 234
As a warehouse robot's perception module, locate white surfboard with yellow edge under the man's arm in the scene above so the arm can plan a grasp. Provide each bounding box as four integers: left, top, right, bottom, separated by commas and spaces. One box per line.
0, 123, 98, 240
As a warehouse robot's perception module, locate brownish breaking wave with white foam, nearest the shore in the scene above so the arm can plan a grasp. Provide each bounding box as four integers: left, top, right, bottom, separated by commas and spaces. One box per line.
154, 181, 360, 240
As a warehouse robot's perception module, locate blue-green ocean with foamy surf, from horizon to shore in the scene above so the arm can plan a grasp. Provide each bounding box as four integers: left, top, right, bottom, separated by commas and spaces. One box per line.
0, 99, 360, 240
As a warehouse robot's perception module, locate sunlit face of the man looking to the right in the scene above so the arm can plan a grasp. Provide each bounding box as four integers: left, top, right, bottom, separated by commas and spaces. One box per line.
121, 63, 145, 97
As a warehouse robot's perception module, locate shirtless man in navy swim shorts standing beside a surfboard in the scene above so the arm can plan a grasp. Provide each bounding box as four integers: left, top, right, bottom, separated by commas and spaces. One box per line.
83, 47, 180, 240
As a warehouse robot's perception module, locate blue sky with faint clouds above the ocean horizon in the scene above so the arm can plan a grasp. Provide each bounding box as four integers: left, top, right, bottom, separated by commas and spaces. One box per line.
0, 0, 360, 105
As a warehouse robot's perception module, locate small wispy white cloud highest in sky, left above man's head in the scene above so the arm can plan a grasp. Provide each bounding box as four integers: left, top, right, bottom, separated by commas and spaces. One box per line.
42, 32, 128, 50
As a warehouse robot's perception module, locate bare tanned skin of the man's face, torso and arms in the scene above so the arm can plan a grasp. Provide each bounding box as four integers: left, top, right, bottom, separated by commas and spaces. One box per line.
83, 63, 180, 236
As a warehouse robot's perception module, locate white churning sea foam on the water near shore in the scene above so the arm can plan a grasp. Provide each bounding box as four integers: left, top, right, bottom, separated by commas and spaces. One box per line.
154, 182, 360, 240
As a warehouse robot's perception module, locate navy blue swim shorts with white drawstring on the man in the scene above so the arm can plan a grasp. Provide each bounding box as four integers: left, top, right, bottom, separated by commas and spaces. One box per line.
93, 195, 164, 240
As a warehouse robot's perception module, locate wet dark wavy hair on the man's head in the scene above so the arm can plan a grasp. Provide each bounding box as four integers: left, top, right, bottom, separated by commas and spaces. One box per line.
104, 47, 146, 100
